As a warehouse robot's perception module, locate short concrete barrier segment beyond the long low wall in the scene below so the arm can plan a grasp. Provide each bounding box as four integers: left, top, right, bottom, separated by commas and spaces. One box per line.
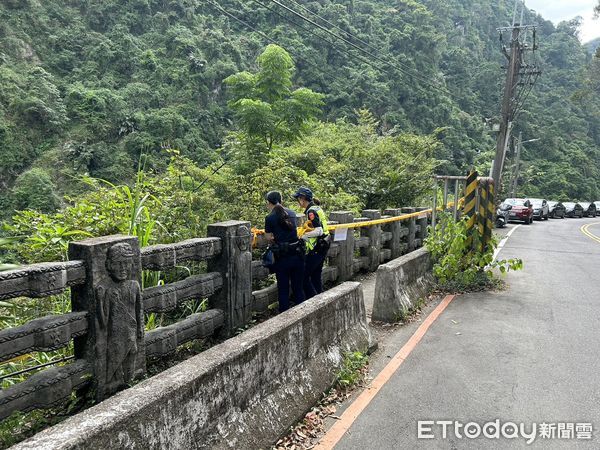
371, 248, 433, 323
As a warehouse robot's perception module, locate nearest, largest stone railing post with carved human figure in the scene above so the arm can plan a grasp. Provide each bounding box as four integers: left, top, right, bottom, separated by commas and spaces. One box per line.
69, 236, 146, 401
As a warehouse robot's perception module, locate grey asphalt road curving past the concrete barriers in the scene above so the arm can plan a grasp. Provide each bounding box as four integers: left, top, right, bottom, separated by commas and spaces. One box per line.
335, 218, 600, 450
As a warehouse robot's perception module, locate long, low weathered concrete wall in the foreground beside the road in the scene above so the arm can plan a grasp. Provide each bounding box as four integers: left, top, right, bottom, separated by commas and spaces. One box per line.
14, 282, 371, 450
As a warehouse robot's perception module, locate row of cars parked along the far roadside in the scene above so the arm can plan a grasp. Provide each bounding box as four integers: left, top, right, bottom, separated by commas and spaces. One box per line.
496, 198, 600, 227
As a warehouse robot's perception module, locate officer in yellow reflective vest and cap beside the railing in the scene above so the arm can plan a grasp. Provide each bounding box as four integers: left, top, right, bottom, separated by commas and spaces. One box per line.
294, 187, 329, 299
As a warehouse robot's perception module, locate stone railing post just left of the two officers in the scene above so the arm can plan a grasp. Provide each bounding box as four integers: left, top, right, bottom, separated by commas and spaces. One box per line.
207, 220, 252, 336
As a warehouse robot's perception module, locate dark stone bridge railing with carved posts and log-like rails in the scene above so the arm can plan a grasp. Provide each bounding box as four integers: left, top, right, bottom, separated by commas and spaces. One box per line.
0, 208, 428, 420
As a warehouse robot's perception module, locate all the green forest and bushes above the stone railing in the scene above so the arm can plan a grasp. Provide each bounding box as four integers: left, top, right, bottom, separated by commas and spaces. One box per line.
0, 0, 600, 259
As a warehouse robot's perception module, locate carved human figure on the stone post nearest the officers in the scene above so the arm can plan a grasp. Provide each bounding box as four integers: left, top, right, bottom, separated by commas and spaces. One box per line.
233, 225, 252, 326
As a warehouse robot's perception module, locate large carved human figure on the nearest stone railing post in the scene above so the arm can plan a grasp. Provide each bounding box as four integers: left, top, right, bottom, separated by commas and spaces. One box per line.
96, 243, 144, 395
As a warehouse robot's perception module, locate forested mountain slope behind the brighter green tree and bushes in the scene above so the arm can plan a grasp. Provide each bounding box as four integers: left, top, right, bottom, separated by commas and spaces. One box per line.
0, 0, 600, 206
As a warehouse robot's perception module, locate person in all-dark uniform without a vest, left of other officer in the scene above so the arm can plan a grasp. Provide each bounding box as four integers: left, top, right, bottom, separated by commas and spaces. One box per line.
265, 191, 304, 312
